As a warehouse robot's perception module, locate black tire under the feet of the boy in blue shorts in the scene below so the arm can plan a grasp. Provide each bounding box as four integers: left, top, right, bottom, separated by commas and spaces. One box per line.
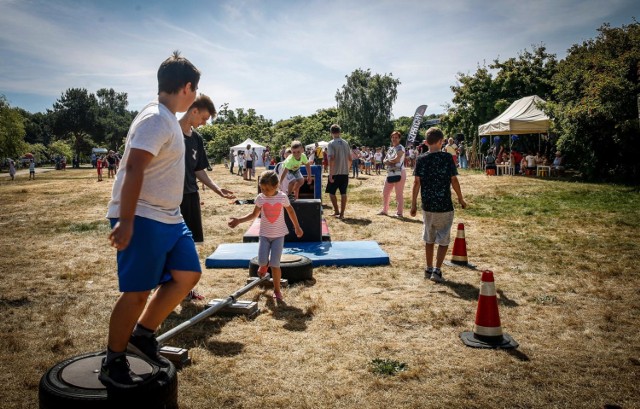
38, 351, 178, 409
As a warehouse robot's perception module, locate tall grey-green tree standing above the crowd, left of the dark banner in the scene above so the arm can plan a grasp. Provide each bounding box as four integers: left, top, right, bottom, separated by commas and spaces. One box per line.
336, 69, 400, 146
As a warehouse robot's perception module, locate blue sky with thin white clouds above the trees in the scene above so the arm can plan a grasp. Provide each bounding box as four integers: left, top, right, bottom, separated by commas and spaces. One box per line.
0, 0, 640, 121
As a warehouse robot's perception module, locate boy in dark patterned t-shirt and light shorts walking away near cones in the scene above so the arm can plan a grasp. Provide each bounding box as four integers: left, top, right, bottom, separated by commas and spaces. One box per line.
411, 127, 467, 283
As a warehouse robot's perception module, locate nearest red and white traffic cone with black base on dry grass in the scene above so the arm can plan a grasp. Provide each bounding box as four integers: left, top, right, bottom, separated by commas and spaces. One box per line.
460, 270, 518, 349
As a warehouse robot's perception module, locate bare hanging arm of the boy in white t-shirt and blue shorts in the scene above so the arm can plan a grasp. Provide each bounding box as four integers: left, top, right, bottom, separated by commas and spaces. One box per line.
109, 148, 153, 251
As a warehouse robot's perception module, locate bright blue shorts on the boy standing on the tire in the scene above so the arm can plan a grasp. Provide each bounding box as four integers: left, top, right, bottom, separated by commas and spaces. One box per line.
110, 216, 202, 292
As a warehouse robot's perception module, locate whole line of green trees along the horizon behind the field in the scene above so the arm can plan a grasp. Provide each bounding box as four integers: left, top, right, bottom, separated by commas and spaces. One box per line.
0, 20, 640, 183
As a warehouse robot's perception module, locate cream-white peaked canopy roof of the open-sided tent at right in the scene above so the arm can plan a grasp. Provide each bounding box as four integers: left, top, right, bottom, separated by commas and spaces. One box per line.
478, 95, 550, 135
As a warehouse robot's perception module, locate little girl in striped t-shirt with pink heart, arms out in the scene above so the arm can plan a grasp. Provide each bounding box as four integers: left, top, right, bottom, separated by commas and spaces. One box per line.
229, 170, 303, 301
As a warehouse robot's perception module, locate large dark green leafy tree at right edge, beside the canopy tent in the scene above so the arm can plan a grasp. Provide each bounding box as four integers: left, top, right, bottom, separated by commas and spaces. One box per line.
547, 21, 640, 184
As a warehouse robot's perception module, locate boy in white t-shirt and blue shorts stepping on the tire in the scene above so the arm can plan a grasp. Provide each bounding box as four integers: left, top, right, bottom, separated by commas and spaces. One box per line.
98, 51, 202, 388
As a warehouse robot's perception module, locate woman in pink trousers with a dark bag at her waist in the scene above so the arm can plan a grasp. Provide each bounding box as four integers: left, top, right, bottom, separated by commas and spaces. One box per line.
378, 131, 407, 217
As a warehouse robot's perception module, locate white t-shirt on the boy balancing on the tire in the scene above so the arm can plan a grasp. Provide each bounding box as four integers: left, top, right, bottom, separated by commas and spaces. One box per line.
107, 101, 185, 224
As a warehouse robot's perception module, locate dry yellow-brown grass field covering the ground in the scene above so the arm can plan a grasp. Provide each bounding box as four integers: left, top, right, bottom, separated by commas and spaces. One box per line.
0, 165, 640, 409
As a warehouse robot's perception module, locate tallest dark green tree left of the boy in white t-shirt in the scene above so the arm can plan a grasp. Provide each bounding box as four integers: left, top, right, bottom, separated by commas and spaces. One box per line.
48, 88, 98, 159
